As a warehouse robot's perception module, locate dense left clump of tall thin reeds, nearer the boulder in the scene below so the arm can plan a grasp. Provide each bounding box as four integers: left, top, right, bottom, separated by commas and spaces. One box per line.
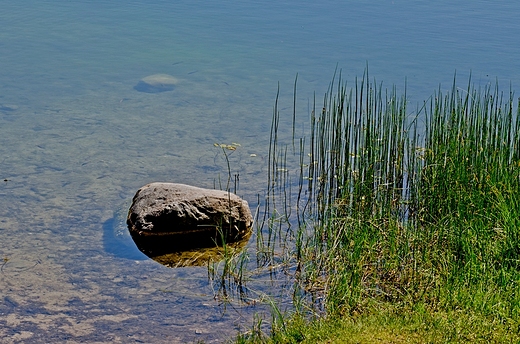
299, 74, 416, 314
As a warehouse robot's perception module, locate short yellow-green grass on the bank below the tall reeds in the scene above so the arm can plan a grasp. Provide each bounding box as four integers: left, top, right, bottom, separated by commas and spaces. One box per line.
247, 304, 518, 344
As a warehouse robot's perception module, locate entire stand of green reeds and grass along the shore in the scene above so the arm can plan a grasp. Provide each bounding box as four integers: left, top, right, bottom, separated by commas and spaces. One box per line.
216, 71, 520, 343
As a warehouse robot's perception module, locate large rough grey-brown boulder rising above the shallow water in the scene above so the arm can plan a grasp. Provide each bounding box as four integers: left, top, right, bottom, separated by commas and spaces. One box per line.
127, 183, 253, 256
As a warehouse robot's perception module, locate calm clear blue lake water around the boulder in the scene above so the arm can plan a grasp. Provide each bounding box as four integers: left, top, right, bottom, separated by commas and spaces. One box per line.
0, 0, 520, 343
